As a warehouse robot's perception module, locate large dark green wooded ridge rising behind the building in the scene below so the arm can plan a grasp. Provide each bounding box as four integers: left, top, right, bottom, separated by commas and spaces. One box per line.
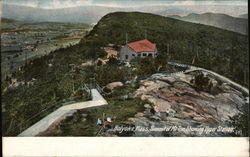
82, 12, 248, 84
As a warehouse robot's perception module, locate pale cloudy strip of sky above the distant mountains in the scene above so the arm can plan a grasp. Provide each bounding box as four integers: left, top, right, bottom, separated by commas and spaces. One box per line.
3, 0, 248, 9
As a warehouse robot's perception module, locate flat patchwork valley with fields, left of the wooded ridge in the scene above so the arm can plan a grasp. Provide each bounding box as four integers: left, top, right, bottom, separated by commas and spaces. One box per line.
1, 19, 91, 78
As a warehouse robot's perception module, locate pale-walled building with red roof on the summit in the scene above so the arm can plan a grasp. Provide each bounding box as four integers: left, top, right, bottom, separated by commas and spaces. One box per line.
119, 39, 157, 61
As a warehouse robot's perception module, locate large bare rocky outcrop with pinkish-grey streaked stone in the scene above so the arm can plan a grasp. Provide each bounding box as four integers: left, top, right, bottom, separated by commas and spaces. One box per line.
119, 73, 248, 136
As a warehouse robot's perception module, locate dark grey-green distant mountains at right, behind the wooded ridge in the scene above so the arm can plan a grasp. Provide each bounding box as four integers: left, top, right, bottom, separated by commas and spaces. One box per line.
169, 13, 248, 34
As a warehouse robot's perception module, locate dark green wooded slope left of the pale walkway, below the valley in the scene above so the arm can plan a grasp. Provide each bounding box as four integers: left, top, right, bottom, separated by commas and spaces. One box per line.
2, 45, 97, 136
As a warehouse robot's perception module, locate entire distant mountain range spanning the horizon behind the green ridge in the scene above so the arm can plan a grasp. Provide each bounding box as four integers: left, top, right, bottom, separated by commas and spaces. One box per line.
2, 4, 248, 34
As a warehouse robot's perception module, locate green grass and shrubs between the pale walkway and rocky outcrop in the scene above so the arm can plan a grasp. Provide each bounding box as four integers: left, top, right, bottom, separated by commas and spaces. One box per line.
48, 85, 145, 136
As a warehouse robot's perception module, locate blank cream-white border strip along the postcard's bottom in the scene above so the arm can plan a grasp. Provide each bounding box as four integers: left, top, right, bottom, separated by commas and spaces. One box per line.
2, 137, 249, 157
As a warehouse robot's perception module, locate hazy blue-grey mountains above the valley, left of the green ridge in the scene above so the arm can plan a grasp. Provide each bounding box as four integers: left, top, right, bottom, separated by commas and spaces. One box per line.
2, 4, 114, 23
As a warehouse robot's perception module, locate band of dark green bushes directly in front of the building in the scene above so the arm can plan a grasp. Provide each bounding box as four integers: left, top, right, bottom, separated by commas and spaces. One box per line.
95, 57, 170, 86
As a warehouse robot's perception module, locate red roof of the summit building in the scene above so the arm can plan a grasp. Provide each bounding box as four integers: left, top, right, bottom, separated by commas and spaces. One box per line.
128, 39, 156, 53
